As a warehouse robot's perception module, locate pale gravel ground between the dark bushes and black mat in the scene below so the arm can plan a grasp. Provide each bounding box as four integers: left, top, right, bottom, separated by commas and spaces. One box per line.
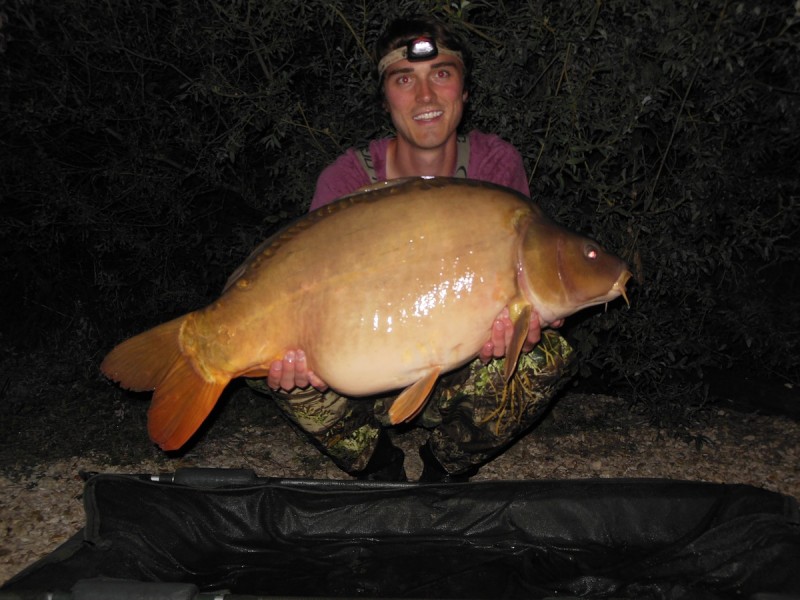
0, 394, 800, 581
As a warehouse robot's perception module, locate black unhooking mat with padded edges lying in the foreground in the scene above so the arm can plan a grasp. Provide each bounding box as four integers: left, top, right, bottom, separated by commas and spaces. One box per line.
0, 470, 800, 599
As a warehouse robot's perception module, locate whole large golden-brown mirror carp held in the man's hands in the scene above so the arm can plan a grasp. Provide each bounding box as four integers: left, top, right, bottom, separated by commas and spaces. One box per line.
101, 178, 630, 450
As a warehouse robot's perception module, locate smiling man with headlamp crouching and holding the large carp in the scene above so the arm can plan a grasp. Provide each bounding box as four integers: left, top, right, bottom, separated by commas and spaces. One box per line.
245, 19, 572, 481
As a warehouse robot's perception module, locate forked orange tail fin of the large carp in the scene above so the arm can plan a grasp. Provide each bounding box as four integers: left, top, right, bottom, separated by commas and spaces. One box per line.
100, 316, 229, 450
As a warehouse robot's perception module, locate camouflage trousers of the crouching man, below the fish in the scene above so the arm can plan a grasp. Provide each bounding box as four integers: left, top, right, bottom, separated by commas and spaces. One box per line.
248, 330, 575, 473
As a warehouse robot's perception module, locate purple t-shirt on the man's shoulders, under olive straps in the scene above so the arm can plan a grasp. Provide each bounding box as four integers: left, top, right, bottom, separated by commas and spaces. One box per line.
310, 130, 531, 210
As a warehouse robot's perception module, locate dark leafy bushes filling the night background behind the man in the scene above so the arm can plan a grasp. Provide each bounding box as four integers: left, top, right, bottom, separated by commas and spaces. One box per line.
0, 0, 800, 422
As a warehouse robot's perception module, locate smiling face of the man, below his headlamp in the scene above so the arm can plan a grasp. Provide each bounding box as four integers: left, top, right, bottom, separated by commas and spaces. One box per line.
383, 54, 467, 149
